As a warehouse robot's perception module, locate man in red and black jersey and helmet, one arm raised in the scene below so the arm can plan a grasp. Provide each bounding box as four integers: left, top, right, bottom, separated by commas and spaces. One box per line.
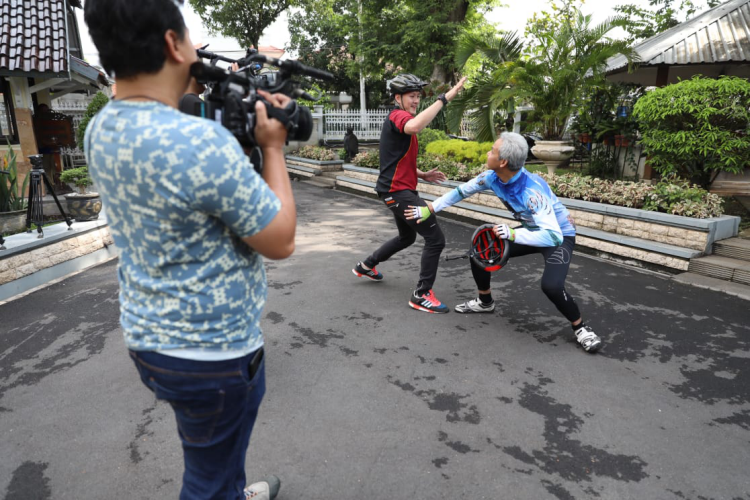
352, 73, 466, 313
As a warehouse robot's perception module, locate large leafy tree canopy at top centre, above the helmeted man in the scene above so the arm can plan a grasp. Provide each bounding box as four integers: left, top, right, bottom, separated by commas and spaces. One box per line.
287, 0, 499, 101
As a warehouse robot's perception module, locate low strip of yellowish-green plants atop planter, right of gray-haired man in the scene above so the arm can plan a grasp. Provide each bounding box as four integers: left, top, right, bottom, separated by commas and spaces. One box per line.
539, 174, 722, 219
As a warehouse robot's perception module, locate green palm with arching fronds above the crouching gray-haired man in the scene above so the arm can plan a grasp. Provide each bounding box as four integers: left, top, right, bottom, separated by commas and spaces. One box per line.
447, 8, 638, 141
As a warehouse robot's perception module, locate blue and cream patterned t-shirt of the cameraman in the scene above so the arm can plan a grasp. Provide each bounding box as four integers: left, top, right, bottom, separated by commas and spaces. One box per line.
85, 101, 281, 352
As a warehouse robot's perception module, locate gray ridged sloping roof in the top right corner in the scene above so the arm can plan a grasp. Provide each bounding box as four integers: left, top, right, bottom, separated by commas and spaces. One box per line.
607, 0, 750, 72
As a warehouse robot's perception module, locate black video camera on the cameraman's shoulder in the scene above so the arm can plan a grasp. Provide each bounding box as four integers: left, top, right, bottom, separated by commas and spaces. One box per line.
190, 49, 333, 171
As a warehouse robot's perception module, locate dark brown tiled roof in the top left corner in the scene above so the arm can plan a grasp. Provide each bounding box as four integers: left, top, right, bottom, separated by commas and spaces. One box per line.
0, 0, 69, 76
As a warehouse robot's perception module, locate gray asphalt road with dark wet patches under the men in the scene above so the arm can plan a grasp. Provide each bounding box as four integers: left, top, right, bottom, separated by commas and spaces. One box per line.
0, 183, 750, 500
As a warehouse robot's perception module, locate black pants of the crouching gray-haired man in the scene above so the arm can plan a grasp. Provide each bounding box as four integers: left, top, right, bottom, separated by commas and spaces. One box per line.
471, 236, 581, 323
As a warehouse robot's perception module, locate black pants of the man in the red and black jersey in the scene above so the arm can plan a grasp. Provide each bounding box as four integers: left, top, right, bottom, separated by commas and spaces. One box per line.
364, 190, 445, 294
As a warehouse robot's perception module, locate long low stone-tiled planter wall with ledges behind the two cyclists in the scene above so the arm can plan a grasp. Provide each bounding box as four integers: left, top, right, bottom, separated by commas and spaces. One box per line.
336, 165, 740, 272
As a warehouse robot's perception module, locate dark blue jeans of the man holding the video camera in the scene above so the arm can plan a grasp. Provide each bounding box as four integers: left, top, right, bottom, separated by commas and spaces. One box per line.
130, 349, 266, 500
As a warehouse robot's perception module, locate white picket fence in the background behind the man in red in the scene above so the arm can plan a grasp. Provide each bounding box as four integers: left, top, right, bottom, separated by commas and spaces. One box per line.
323, 109, 474, 141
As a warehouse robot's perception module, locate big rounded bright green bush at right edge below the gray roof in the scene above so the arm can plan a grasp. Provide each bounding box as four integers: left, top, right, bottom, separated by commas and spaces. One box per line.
633, 76, 750, 187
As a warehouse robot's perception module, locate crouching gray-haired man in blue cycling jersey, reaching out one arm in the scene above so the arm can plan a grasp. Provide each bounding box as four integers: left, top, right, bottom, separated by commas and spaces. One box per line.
408, 132, 602, 353
